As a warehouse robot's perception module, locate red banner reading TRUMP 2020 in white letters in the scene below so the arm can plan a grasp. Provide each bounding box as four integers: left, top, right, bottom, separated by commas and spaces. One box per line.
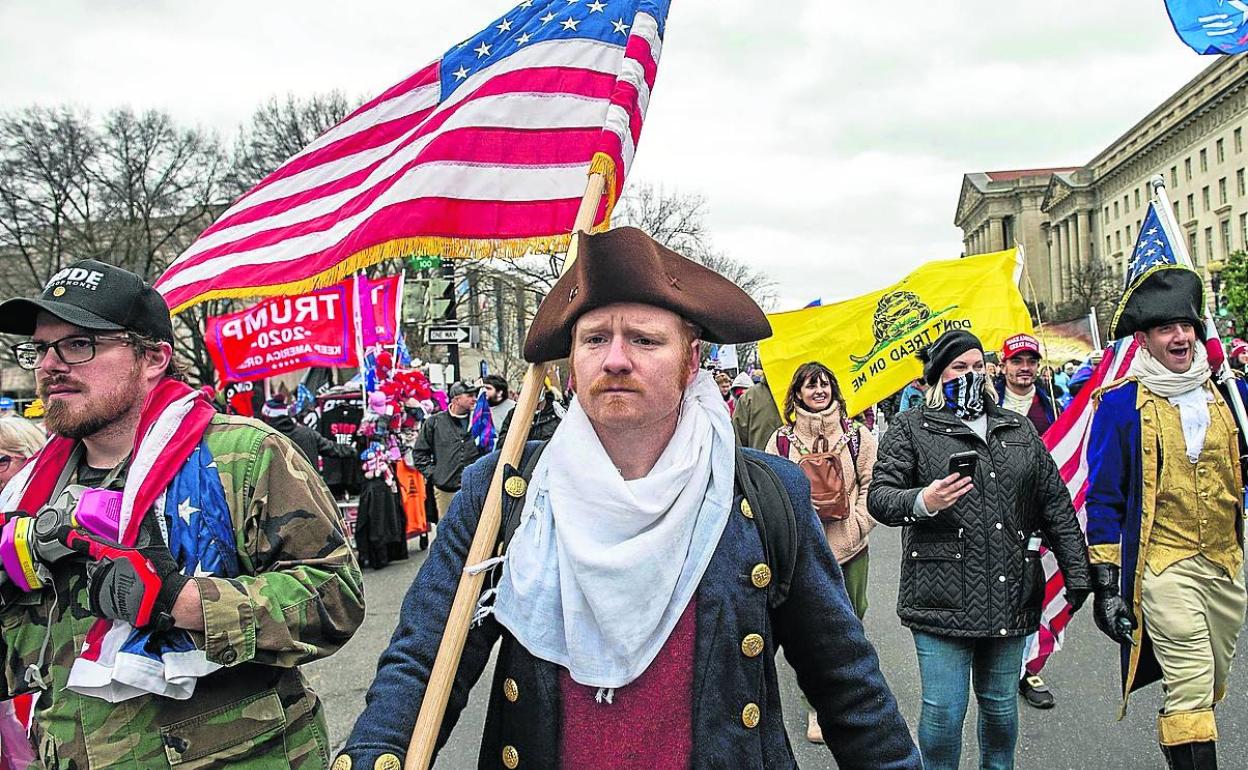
203, 281, 358, 384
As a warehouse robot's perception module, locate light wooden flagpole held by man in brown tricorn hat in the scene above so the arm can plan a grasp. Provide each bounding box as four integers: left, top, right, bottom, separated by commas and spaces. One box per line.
403, 173, 607, 770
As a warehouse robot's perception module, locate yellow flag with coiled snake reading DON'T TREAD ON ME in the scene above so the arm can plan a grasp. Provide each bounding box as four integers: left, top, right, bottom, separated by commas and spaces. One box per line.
759, 248, 1032, 414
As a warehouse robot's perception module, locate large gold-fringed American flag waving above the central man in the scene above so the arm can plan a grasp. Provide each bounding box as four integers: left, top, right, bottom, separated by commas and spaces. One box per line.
156, 0, 670, 312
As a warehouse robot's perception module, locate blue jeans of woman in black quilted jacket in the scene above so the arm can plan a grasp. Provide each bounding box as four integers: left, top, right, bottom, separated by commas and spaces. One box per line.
914, 630, 1027, 770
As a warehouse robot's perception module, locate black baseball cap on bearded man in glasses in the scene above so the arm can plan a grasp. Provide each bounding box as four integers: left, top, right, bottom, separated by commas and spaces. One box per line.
0, 260, 173, 344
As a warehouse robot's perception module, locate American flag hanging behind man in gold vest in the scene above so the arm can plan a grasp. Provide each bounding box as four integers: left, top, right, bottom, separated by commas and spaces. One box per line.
1023, 203, 1177, 673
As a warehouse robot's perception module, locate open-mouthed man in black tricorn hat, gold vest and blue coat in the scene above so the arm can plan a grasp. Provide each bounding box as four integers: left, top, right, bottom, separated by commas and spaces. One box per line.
1087, 265, 1246, 770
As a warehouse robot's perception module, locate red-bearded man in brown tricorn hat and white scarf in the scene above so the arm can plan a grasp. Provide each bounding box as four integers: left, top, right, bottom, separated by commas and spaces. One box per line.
334, 228, 920, 770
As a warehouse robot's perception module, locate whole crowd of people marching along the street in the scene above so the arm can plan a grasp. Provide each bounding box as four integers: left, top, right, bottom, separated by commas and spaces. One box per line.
0, 227, 1233, 770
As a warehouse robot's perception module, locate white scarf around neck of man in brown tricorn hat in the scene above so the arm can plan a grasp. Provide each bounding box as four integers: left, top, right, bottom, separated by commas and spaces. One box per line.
494, 372, 735, 688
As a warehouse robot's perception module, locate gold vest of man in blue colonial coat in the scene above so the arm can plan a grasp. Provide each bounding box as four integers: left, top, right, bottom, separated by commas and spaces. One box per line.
1141, 384, 1243, 577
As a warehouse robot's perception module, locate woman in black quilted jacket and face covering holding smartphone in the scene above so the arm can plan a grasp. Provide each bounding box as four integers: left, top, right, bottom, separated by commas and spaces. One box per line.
867, 331, 1091, 770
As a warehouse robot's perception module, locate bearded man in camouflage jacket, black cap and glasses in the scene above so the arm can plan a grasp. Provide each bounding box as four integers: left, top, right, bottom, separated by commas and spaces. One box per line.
0, 261, 364, 770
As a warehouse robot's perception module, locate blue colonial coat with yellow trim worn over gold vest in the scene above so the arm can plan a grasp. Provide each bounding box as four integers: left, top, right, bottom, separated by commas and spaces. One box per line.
1087, 379, 1248, 719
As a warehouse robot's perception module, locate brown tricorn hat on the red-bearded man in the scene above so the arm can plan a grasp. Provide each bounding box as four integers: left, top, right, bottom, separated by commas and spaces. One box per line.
524, 227, 771, 363
